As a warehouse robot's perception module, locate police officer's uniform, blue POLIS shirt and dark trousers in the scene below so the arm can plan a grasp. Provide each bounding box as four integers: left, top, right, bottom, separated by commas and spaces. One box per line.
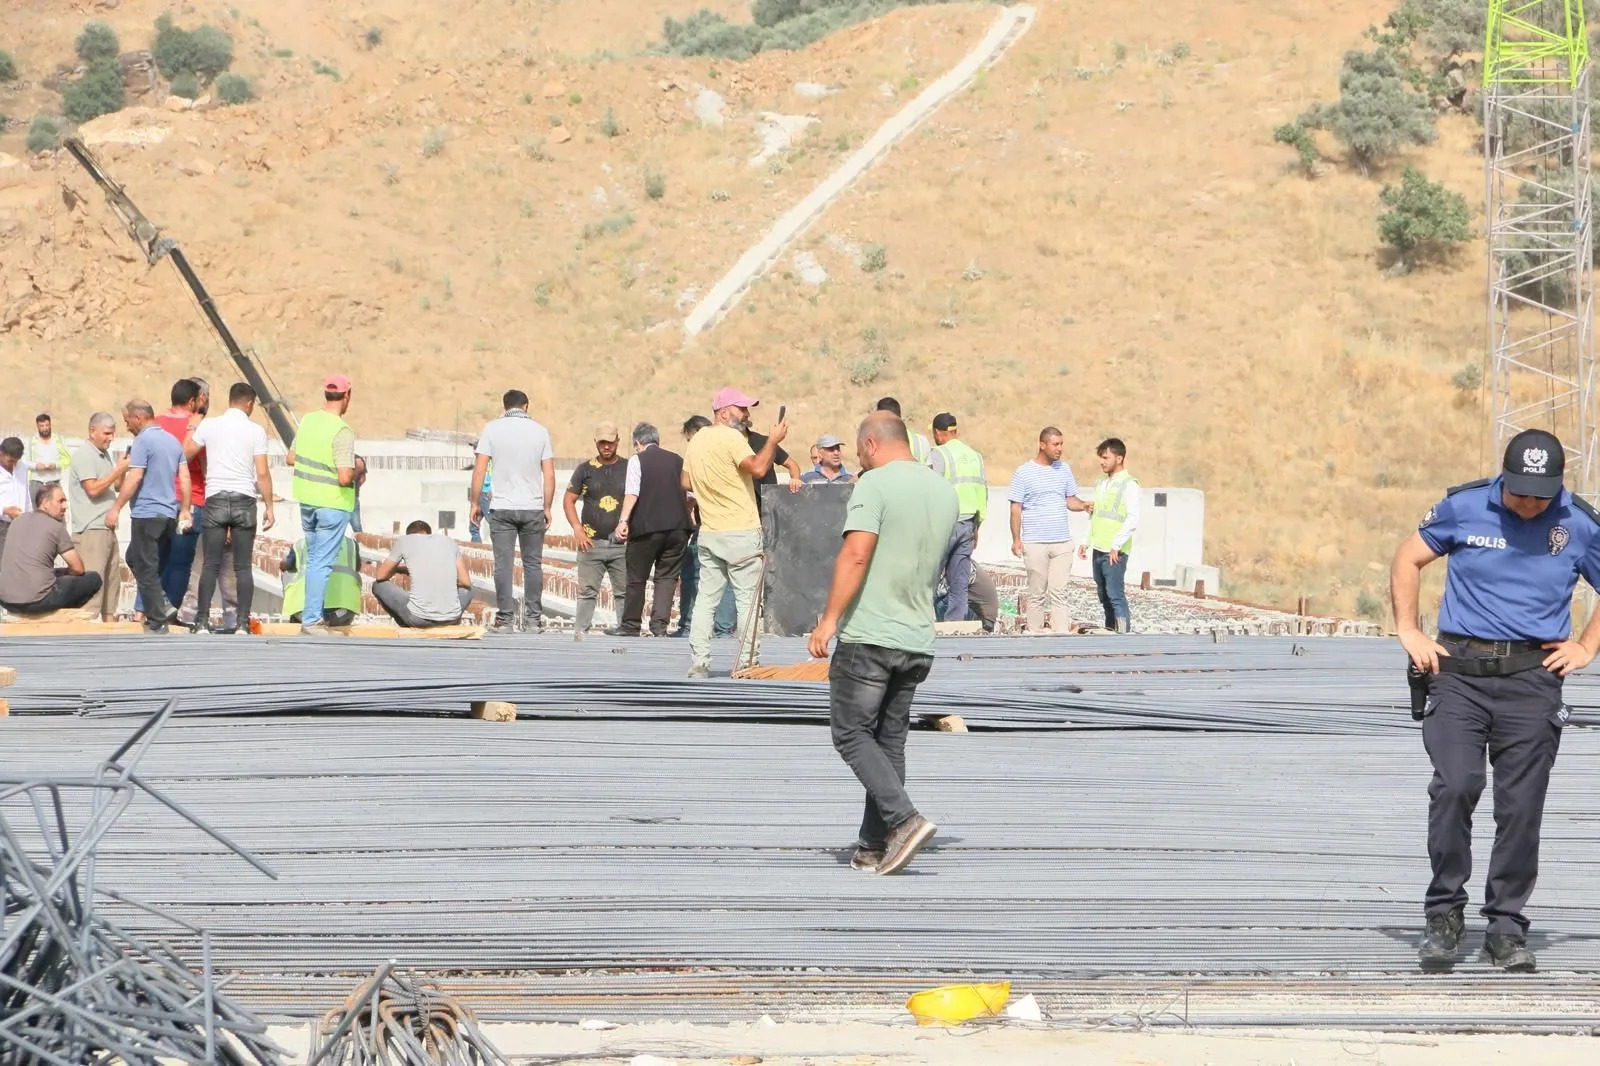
1418, 475, 1600, 938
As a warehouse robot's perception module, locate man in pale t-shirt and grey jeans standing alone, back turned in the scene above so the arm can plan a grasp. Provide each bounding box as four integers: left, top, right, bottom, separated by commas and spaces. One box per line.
467, 389, 555, 632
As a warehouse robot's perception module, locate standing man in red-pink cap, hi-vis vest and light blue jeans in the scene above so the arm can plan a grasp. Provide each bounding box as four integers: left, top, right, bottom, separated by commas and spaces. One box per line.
288, 375, 355, 637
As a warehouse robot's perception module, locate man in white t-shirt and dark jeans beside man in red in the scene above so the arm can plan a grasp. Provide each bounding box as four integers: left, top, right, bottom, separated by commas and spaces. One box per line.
184, 381, 274, 634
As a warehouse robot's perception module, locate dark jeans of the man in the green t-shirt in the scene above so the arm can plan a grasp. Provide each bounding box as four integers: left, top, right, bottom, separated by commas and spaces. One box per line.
827, 640, 933, 850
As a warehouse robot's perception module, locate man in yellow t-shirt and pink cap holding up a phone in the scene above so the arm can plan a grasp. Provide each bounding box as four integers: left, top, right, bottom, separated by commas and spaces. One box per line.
683, 387, 789, 677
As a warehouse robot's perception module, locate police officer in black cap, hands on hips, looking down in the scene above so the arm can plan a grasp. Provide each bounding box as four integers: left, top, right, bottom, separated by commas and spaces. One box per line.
1389, 429, 1600, 973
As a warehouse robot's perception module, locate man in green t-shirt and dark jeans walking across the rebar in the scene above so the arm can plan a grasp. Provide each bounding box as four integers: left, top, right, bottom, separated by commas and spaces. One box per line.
811, 411, 960, 874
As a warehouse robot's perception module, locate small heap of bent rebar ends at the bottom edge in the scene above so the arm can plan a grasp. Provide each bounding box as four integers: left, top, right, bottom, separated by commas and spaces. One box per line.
306, 964, 510, 1066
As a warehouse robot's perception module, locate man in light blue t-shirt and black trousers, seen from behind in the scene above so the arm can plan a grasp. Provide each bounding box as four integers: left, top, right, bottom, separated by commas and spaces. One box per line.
106, 400, 192, 632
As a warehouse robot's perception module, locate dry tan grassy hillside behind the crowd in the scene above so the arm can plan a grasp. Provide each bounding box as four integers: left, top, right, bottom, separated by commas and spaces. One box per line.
0, 0, 1485, 610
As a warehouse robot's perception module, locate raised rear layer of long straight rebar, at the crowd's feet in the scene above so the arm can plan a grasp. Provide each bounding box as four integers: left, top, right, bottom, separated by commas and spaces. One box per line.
6, 635, 1529, 736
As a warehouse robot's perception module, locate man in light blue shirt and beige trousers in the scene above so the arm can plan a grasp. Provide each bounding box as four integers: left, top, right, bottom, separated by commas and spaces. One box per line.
1010, 426, 1094, 632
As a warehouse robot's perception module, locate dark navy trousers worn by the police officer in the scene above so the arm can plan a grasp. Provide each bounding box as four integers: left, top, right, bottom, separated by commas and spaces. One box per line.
1422, 640, 1566, 936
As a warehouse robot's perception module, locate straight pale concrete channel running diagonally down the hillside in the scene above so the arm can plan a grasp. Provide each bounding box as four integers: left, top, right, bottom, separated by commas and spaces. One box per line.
683, 3, 1034, 336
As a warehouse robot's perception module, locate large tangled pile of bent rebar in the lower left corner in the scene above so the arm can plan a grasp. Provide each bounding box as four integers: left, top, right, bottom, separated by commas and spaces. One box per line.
0, 704, 280, 1066
